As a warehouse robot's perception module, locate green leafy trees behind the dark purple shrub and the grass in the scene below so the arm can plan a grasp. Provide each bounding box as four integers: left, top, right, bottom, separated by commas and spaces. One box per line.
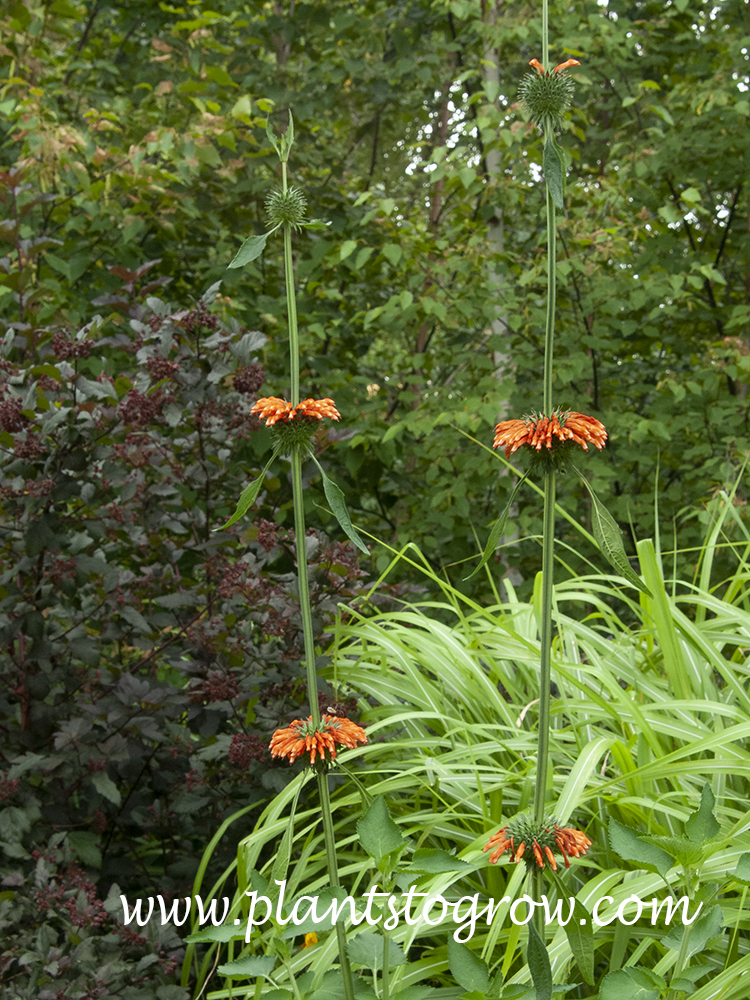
0, 0, 750, 590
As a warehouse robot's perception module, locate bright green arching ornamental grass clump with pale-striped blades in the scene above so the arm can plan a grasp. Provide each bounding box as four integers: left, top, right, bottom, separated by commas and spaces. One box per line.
187, 482, 750, 1000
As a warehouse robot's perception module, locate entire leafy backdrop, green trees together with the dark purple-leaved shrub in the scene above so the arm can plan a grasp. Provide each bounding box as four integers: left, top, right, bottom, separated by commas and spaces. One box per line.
0, 0, 750, 1000
